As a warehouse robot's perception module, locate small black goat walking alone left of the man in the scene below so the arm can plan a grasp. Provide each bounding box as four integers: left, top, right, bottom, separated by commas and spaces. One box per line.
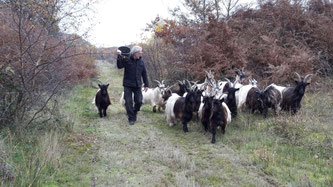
95, 84, 111, 118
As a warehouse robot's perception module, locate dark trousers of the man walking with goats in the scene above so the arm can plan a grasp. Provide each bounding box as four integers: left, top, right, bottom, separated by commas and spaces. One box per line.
124, 86, 142, 121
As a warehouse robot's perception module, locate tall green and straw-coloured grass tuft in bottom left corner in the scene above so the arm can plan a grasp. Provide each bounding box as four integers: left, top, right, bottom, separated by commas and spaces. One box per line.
0, 131, 61, 186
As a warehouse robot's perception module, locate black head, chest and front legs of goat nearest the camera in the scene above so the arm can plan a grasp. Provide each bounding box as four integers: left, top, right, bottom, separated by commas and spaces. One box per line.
209, 98, 228, 143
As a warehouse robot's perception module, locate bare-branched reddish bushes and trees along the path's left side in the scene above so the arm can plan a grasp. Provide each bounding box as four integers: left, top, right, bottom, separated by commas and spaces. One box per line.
0, 0, 96, 128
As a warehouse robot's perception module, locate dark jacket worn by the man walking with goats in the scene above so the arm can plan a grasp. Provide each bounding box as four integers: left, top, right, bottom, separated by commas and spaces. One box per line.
117, 55, 149, 88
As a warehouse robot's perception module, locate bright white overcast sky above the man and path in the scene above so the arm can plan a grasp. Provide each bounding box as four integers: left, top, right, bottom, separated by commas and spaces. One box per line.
88, 0, 179, 47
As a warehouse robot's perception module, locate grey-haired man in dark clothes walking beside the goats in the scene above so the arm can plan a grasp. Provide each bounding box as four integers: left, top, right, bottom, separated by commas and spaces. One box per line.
117, 46, 149, 125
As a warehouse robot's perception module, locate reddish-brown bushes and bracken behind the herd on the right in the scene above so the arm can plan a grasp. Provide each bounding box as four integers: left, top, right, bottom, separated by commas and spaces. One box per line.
147, 0, 333, 85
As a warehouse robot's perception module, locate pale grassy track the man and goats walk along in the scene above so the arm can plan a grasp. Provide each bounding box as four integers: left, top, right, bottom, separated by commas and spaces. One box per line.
67, 61, 278, 186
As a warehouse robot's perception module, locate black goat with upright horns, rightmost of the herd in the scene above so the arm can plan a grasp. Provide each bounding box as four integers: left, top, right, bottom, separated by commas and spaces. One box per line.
281, 72, 312, 114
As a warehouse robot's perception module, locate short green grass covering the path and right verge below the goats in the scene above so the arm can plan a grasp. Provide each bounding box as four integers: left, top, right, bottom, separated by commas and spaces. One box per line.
0, 62, 333, 186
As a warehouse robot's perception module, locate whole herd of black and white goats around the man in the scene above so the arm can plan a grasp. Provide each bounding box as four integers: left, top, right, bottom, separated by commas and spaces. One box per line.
95, 68, 311, 143
